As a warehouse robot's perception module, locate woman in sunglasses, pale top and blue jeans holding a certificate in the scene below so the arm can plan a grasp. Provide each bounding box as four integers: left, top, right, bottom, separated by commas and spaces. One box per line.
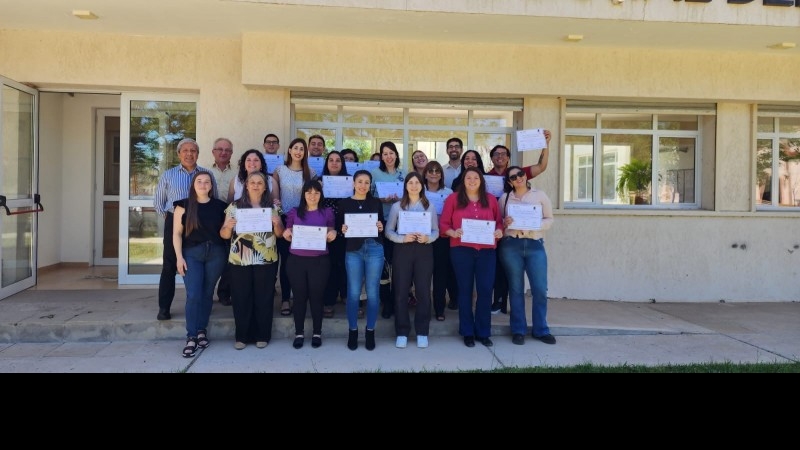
500, 166, 556, 345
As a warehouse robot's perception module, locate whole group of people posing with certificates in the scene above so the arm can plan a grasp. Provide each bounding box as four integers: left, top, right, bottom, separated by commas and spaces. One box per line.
154, 131, 555, 358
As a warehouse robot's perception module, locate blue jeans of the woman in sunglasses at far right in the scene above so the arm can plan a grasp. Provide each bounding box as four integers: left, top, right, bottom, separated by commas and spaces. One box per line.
500, 238, 550, 337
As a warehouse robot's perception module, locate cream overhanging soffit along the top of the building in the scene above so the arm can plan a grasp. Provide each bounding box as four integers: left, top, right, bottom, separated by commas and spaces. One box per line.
0, 0, 800, 55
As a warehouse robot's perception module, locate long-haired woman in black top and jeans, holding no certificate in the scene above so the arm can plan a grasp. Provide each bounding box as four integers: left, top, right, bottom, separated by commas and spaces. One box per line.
172, 172, 228, 358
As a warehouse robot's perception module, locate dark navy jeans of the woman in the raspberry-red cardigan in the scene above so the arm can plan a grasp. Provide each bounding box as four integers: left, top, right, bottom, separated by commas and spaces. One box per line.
450, 246, 497, 338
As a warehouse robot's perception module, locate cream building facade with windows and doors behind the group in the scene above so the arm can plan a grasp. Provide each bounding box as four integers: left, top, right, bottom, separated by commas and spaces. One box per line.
0, 0, 800, 302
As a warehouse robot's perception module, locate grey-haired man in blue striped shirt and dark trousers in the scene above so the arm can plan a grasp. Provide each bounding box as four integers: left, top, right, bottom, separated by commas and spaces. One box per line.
153, 138, 217, 320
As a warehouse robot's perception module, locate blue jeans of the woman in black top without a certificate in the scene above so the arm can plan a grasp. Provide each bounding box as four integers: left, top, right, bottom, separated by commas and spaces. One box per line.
183, 242, 228, 337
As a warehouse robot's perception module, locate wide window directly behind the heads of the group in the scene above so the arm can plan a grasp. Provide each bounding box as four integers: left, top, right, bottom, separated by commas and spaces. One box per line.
292, 92, 522, 171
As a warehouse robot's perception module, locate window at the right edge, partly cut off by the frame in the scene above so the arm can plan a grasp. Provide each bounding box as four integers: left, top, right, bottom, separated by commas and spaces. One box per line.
755, 107, 800, 210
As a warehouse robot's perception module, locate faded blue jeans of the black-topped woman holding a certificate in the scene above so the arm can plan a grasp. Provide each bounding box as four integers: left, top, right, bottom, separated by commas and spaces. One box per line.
344, 239, 383, 330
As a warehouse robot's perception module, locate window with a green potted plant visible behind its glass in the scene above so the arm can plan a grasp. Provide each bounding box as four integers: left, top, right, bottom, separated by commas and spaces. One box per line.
563, 101, 715, 208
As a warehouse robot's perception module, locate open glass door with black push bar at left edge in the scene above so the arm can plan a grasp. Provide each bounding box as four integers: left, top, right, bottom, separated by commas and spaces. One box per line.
0, 76, 42, 299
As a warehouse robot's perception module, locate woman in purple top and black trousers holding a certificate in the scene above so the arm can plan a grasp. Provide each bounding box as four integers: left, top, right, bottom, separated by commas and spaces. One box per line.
283, 180, 336, 349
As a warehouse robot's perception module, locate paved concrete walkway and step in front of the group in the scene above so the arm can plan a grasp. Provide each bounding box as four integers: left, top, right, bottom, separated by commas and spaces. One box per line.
0, 289, 800, 373
